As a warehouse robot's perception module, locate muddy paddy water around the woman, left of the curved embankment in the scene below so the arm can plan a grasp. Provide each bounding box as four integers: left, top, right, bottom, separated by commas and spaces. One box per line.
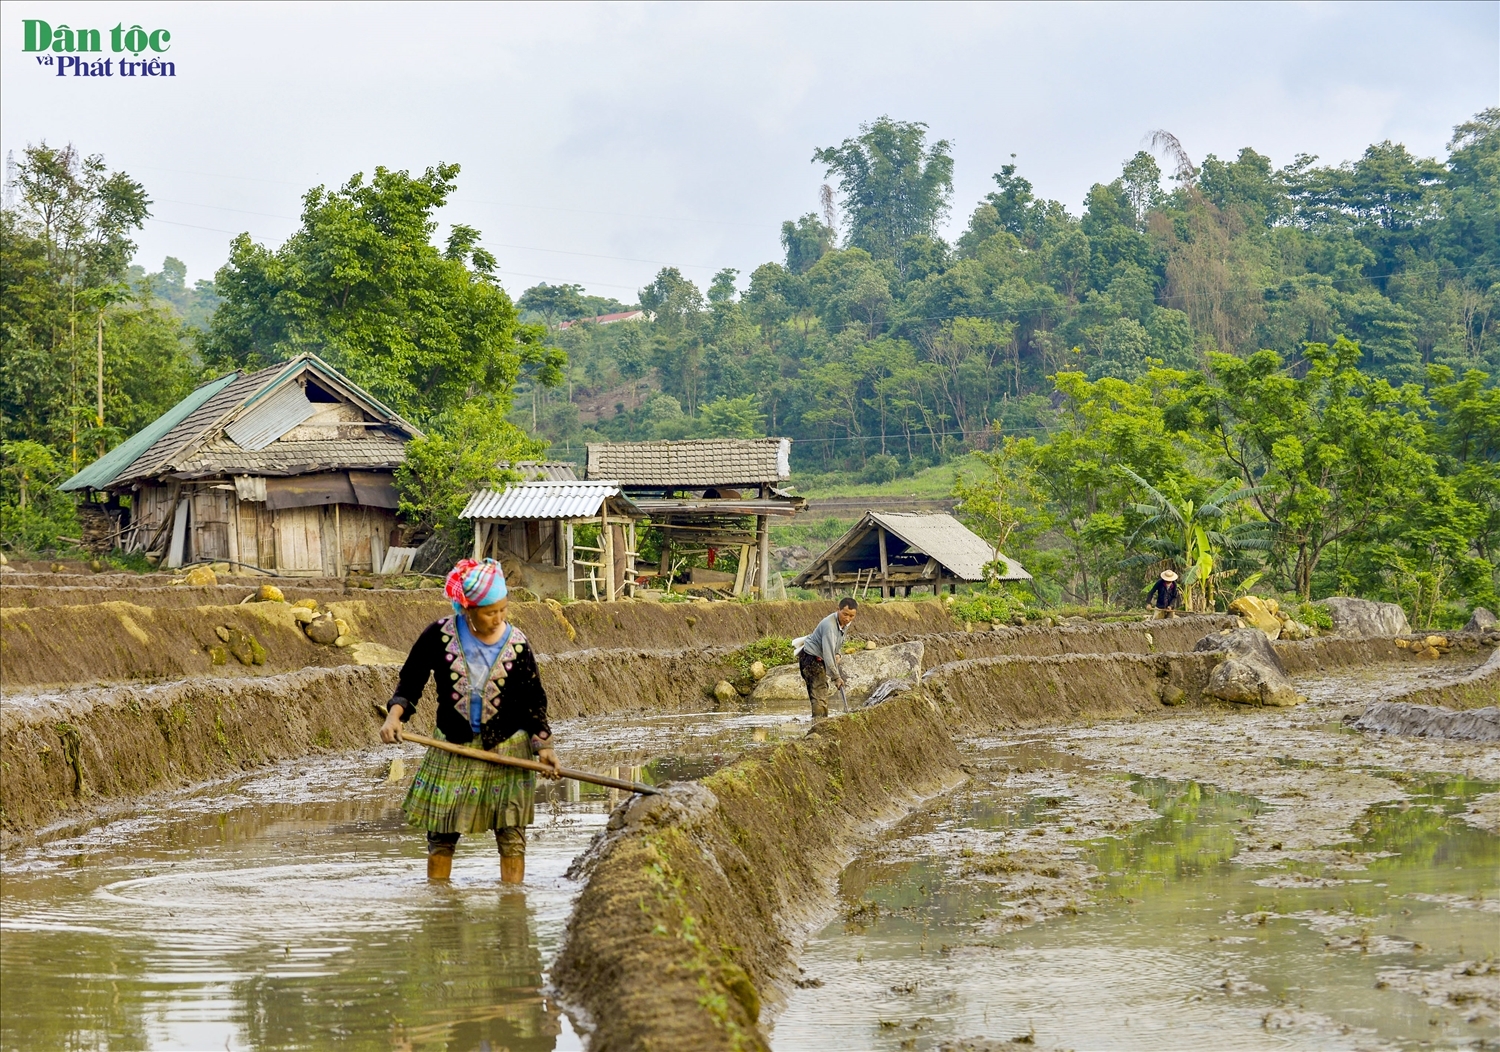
0, 713, 807, 1052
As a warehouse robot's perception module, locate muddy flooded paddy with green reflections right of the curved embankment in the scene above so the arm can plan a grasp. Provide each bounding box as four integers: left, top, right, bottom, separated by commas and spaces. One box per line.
773, 671, 1500, 1052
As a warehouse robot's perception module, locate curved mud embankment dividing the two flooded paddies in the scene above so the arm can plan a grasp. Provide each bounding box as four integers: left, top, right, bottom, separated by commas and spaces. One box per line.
554, 627, 1488, 1052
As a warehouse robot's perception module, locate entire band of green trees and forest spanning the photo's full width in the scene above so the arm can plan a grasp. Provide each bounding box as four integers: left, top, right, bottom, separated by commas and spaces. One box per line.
0, 110, 1500, 623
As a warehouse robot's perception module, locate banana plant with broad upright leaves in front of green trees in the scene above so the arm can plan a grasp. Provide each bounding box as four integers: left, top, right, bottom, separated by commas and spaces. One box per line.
1119, 465, 1271, 611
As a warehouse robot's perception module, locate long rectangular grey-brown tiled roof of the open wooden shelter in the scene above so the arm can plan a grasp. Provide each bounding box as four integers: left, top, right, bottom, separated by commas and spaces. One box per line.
588, 438, 792, 489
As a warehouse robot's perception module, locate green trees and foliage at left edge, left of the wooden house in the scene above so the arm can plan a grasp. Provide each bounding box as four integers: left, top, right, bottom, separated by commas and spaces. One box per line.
0, 143, 198, 548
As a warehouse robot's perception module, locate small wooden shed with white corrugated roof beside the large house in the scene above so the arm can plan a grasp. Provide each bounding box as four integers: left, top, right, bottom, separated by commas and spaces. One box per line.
461, 483, 642, 602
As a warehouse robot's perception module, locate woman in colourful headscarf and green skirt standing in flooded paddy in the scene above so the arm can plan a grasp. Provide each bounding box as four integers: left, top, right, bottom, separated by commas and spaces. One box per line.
381, 558, 558, 884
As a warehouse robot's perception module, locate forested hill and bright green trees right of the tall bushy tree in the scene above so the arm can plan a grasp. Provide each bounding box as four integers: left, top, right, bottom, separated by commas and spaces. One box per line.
515, 110, 1500, 623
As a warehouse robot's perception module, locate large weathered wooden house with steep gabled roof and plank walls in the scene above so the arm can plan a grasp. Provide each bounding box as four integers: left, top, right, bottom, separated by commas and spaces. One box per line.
62, 354, 422, 576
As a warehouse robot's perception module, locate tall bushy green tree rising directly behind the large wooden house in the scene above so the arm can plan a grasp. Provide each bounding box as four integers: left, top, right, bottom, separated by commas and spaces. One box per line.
203, 164, 566, 423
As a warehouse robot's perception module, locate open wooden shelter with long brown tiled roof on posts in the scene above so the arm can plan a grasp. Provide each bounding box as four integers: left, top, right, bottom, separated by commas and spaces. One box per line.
587, 438, 807, 596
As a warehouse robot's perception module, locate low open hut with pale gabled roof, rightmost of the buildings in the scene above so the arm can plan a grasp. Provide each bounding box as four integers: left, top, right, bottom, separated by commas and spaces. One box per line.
795, 512, 1032, 597
